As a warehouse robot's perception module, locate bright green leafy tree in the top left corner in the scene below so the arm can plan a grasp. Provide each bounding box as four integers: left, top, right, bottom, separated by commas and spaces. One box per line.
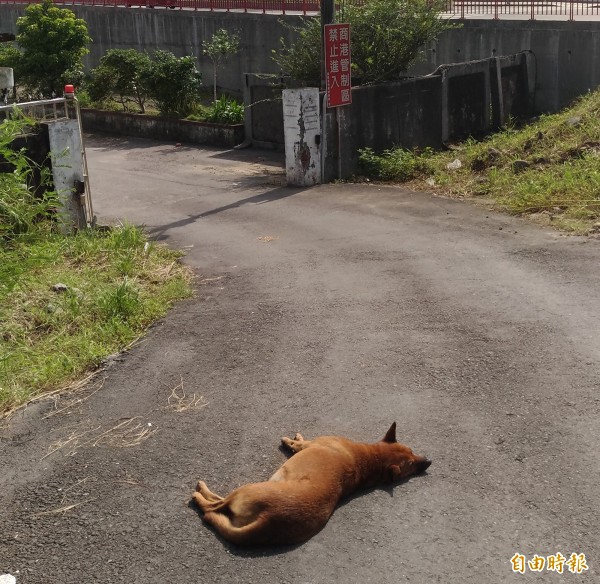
17, 0, 92, 96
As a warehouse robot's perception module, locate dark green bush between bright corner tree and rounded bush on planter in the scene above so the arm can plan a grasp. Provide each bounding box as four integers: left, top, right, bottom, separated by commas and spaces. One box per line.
87, 49, 152, 113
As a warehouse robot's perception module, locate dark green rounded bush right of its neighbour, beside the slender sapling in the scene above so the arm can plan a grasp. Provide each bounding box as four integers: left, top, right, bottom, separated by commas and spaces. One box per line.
141, 50, 202, 118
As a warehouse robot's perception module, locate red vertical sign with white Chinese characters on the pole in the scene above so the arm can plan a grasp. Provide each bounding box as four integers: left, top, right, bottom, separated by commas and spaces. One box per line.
325, 24, 352, 107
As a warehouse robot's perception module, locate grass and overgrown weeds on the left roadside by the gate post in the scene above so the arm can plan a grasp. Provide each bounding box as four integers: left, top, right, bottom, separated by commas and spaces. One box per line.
0, 120, 190, 413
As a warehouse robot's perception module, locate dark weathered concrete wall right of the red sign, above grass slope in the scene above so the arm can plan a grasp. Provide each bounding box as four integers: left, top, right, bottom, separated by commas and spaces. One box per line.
323, 54, 530, 182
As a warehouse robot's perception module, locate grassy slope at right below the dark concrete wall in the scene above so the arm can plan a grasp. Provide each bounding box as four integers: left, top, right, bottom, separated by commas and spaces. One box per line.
361, 86, 600, 234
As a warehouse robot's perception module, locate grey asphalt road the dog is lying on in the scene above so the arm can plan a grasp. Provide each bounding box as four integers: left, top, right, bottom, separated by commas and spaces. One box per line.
0, 138, 600, 584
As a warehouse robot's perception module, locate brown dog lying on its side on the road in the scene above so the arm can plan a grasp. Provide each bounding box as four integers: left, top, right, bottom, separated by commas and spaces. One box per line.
192, 422, 431, 545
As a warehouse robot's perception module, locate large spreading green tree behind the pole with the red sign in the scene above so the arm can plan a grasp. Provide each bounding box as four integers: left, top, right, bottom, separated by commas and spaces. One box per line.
274, 0, 456, 86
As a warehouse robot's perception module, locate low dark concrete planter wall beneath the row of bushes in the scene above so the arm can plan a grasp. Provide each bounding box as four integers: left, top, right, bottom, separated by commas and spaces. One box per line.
81, 108, 244, 148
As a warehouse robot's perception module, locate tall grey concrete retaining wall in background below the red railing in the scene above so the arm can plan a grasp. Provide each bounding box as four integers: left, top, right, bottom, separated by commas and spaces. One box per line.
0, 5, 600, 113
